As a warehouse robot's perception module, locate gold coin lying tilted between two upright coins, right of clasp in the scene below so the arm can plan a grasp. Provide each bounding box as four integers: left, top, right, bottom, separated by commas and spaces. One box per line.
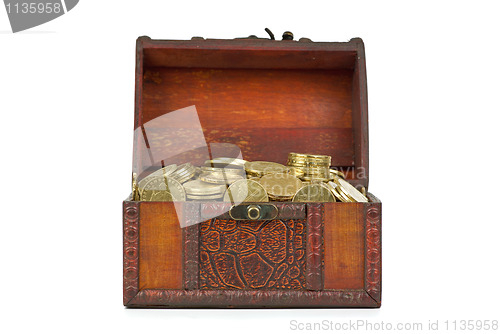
259, 173, 302, 199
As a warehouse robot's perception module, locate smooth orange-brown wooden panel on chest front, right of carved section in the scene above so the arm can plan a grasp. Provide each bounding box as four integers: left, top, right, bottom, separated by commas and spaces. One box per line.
324, 203, 365, 290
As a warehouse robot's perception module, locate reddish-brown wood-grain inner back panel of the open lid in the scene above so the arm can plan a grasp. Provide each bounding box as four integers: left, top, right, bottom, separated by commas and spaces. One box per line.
142, 67, 354, 166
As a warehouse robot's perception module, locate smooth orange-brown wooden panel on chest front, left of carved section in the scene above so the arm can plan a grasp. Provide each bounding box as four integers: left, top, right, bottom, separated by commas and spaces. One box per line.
139, 202, 183, 290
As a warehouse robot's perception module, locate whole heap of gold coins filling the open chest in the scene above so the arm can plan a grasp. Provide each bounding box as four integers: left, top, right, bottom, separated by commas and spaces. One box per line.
133, 153, 368, 204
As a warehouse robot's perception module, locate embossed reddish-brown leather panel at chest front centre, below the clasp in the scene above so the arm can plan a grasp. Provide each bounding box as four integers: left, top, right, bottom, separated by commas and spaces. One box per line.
199, 219, 306, 290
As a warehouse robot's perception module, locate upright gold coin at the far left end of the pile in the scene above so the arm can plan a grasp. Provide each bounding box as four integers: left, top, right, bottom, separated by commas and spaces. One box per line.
139, 177, 186, 202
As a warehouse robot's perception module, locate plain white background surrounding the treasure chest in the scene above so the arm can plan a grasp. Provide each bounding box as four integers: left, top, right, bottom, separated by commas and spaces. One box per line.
0, 0, 500, 333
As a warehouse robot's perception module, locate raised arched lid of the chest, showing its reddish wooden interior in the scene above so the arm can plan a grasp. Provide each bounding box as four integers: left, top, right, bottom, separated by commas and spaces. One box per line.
133, 37, 368, 188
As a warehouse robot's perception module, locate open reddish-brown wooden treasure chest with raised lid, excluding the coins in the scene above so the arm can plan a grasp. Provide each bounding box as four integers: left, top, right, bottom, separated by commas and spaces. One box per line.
123, 35, 381, 308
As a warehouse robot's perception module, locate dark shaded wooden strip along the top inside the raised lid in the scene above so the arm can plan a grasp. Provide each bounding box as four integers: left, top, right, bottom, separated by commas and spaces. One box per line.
142, 37, 357, 69
